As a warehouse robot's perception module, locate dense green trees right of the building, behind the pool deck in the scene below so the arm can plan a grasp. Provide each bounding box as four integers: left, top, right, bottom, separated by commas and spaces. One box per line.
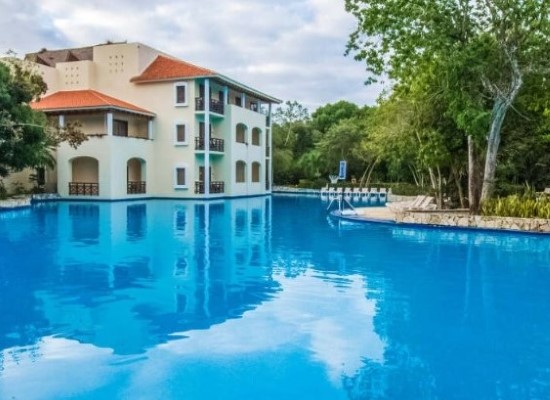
273, 0, 550, 216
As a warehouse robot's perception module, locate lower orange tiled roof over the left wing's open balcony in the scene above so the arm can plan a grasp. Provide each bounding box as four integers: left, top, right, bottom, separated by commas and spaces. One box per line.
31, 90, 154, 115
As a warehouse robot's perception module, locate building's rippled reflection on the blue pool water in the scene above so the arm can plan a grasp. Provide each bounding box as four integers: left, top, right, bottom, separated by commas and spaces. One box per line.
1, 197, 278, 354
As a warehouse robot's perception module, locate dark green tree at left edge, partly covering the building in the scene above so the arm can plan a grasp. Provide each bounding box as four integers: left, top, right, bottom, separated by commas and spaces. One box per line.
0, 58, 86, 178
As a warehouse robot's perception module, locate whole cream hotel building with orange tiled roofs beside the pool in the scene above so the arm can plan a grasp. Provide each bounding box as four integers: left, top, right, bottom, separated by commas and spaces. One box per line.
27, 43, 280, 200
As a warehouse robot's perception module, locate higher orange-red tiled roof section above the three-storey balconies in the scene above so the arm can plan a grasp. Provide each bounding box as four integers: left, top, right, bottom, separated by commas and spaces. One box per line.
130, 56, 217, 82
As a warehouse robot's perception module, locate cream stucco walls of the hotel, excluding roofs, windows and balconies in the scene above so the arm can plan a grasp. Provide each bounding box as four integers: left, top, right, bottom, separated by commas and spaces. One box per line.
31, 43, 274, 198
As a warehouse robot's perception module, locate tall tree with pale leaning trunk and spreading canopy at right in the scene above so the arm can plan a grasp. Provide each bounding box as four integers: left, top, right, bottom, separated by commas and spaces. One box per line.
346, 0, 550, 211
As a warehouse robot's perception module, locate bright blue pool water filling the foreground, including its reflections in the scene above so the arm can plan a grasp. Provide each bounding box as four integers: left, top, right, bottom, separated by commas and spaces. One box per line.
0, 196, 550, 400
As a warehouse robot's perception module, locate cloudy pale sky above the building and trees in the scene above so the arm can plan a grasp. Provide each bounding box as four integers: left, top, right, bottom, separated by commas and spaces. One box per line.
0, 0, 381, 112
